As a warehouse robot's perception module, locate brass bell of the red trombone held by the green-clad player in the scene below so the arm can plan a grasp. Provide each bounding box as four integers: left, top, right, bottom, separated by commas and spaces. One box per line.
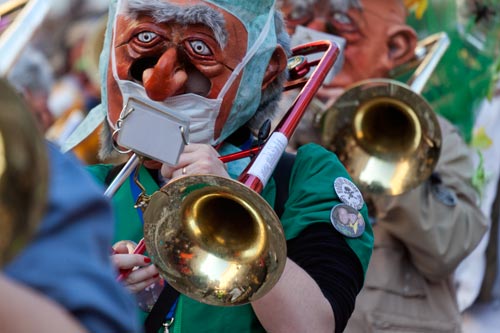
144, 175, 286, 306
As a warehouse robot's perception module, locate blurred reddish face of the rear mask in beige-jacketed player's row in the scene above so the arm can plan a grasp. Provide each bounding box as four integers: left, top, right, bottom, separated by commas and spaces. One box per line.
282, 0, 405, 88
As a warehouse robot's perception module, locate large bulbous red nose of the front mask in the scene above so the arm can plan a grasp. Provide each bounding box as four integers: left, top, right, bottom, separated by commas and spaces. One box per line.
142, 47, 188, 101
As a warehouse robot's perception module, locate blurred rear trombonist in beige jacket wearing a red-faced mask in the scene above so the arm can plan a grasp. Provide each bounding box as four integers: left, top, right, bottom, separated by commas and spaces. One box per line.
281, 0, 487, 333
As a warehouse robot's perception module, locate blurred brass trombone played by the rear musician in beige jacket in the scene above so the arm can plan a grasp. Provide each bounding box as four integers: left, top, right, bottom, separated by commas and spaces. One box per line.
320, 33, 450, 195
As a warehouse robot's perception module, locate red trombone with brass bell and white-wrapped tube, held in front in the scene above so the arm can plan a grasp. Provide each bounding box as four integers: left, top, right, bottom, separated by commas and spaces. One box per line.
107, 41, 340, 306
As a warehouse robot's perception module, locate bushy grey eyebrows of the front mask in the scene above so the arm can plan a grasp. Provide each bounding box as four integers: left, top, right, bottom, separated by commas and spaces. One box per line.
128, 0, 227, 48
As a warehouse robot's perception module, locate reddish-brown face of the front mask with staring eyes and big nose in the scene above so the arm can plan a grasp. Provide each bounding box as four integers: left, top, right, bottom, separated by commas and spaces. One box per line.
107, 0, 247, 137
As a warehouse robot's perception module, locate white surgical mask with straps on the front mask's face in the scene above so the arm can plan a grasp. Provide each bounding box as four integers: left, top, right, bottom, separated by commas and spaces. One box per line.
108, 0, 273, 145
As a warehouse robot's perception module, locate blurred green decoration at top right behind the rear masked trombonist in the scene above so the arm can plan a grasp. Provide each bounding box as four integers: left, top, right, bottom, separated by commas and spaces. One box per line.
408, 0, 500, 142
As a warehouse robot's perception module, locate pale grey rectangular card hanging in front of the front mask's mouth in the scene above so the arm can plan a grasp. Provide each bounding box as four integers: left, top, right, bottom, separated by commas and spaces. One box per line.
117, 97, 189, 165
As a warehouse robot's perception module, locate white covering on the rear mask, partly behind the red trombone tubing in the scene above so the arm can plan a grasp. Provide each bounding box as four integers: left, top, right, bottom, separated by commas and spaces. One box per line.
290, 25, 345, 84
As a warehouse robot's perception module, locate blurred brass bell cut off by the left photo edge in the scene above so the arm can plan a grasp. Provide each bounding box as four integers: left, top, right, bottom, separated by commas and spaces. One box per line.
0, 80, 48, 267
